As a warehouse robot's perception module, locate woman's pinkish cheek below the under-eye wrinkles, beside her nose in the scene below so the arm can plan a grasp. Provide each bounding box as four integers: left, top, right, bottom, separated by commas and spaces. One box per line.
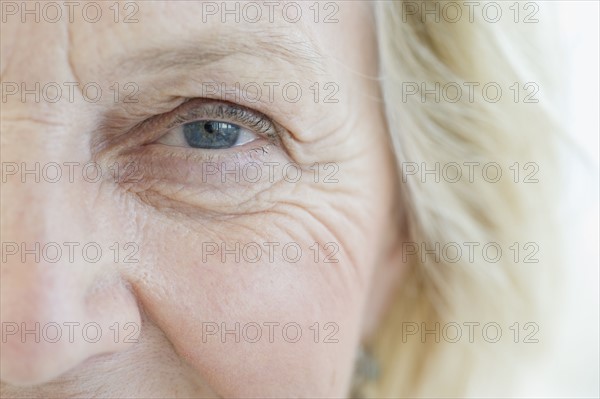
125, 211, 365, 397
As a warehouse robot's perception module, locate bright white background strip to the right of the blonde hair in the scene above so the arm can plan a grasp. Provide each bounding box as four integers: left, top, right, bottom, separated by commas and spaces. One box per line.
540, 0, 600, 398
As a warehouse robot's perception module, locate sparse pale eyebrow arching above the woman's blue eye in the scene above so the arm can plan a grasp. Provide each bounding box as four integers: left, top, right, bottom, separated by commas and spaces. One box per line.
112, 32, 326, 75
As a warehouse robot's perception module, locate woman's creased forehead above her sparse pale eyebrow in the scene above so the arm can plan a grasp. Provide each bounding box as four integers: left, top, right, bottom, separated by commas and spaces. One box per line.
2, 0, 370, 80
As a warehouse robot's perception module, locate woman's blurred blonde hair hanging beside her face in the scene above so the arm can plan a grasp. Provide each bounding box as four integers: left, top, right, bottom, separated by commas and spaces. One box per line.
360, 1, 558, 397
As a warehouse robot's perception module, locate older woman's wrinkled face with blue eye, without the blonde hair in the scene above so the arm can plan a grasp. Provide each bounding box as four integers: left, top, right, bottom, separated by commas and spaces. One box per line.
1, 1, 404, 397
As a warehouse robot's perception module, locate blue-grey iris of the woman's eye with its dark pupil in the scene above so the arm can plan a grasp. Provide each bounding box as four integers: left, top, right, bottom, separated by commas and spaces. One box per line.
183, 121, 241, 149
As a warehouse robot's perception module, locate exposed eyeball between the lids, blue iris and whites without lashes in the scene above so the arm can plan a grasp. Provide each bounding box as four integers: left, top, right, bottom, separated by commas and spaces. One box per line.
158, 120, 257, 150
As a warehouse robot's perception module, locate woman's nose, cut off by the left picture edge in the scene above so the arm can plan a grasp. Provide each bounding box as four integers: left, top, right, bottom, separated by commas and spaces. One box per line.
0, 124, 140, 385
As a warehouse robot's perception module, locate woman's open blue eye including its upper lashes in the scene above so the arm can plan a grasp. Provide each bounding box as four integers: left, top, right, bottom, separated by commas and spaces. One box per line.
157, 102, 275, 150
